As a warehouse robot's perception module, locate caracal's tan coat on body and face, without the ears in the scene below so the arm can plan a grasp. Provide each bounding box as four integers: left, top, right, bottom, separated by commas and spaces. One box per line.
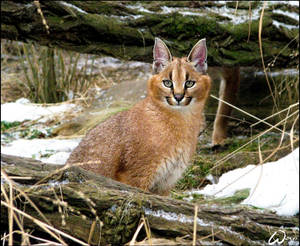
67, 47, 211, 194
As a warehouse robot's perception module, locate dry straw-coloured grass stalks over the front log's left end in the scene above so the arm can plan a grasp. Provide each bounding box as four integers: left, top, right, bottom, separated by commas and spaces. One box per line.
1, 162, 103, 245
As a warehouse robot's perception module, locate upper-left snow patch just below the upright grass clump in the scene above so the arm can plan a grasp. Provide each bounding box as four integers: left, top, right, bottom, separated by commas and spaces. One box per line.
1, 98, 76, 122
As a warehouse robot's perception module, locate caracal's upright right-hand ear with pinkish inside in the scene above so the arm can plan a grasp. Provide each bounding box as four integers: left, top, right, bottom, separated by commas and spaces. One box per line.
187, 38, 207, 73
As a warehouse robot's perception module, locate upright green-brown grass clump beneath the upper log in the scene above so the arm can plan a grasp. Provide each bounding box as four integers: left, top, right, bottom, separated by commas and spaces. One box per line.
20, 44, 94, 103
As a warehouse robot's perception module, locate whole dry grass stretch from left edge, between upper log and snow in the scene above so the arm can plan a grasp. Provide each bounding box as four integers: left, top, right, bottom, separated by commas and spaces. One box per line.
1, 41, 97, 103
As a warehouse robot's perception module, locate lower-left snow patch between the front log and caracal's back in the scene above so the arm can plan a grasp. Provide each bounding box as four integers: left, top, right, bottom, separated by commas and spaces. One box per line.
1, 139, 81, 164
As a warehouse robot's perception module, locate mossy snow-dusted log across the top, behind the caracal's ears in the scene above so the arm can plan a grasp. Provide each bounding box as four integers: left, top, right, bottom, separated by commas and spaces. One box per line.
1, 0, 299, 68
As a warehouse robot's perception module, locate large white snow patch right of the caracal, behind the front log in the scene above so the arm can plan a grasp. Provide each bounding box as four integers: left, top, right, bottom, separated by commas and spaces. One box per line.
191, 148, 299, 216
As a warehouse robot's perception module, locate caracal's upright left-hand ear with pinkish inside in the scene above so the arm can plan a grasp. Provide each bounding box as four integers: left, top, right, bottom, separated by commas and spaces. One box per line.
153, 38, 172, 73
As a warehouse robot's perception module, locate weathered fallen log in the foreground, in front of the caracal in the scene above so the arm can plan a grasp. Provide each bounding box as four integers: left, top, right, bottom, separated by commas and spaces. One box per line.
1, 154, 299, 245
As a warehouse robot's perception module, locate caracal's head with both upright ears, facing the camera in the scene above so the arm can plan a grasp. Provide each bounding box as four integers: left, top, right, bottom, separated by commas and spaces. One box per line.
148, 39, 210, 109
